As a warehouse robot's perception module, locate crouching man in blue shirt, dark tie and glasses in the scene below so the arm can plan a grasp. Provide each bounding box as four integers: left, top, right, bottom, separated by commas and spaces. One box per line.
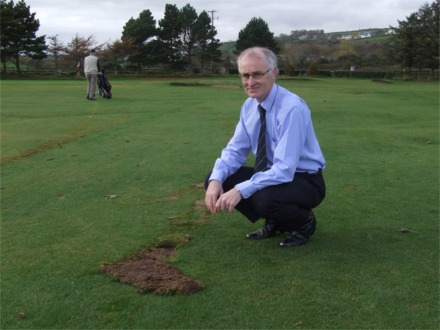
205, 47, 326, 247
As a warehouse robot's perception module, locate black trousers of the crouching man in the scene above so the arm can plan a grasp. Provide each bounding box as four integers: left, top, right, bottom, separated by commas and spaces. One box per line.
205, 166, 325, 231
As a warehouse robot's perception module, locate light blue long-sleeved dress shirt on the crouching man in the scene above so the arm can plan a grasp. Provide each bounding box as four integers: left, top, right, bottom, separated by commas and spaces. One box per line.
210, 84, 325, 198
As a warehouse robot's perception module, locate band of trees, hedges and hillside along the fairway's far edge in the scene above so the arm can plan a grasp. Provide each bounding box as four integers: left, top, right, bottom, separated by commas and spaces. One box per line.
0, 0, 440, 74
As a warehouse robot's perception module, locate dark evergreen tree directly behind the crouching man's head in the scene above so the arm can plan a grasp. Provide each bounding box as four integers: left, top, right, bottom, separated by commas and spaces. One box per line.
234, 17, 280, 54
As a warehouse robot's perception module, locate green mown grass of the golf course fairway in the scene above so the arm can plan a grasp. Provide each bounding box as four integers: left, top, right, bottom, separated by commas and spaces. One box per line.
1, 78, 440, 329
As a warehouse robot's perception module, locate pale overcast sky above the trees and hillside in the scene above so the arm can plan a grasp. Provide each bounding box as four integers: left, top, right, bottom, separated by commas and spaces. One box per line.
25, 0, 433, 43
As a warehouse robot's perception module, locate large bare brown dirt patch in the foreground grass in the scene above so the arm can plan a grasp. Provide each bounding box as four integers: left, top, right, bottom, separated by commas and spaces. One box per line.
102, 247, 204, 295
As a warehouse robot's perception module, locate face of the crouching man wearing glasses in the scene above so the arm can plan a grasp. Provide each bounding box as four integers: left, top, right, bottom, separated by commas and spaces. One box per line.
239, 53, 276, 103
